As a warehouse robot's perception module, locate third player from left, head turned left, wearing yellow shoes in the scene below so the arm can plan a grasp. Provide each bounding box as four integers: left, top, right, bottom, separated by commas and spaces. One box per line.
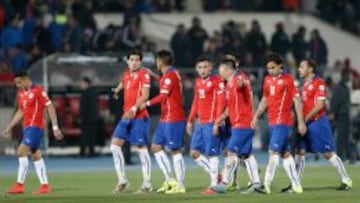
141, 50, 185, 194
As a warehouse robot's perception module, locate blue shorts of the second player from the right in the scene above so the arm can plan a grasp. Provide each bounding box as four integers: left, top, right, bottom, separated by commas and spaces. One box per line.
269, 125, 292, 153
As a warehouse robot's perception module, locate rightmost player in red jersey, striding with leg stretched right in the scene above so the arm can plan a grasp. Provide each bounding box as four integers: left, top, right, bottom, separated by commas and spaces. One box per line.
283, 58, 352, 192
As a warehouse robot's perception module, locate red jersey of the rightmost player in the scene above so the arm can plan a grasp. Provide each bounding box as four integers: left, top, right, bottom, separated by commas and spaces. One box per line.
301, 77, 326, 120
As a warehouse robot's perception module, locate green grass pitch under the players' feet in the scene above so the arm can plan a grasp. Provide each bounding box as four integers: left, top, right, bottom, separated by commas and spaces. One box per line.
0, 166, 360, 203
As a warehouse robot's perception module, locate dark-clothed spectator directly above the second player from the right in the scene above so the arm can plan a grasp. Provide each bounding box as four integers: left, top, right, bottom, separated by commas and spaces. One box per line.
271, 23, 290, 60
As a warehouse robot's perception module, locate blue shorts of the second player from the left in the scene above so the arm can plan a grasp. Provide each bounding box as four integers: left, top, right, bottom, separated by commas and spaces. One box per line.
113, 118, 150, 146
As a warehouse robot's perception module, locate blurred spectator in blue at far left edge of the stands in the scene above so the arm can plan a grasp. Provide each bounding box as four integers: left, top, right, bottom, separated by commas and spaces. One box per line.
1, 14, 24, 49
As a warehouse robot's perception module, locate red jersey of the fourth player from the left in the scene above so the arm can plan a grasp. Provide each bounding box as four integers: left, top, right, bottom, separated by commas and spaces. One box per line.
188, 75, 224, 124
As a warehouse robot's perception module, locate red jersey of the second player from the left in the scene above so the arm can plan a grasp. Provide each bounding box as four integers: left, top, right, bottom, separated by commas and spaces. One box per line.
122, 69, 151, 119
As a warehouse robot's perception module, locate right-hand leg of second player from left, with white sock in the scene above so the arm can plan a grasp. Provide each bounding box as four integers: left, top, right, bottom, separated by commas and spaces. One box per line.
130, 118, 152, 193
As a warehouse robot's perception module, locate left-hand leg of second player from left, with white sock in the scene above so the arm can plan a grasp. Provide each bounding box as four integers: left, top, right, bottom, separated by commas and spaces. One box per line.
110, 120, 131, 194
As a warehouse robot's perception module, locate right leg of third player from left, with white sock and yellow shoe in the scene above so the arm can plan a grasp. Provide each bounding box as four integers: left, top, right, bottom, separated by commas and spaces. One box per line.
165, 122, 185, 194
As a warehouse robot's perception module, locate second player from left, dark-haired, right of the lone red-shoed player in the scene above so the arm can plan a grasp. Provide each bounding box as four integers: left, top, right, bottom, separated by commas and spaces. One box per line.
110, 49, 152, 194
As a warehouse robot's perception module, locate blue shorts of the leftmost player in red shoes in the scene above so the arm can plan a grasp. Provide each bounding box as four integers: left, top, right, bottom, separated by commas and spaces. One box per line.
21, 127, 44, 152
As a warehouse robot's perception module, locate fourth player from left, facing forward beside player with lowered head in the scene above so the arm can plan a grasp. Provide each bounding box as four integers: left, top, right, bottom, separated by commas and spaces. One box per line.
186, 56, 224, 195
